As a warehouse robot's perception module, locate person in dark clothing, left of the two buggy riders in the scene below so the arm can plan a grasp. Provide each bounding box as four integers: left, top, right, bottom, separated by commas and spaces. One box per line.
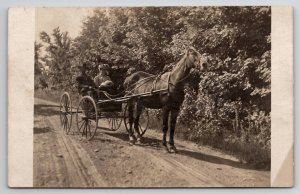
76, 64, 95, 96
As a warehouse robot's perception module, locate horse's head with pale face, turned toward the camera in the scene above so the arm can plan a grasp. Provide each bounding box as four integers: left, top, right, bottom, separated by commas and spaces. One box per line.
186, 47, 208, 71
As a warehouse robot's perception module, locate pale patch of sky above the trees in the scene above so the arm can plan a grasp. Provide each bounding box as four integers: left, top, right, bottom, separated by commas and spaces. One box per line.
35, 7, 93, 42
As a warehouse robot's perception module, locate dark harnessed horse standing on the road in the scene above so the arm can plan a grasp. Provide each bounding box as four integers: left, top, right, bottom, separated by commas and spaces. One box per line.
124, 48, 207, 153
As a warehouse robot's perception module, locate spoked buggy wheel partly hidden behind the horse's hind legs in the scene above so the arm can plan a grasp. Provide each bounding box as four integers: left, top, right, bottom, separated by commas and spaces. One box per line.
124, 105, 149, 136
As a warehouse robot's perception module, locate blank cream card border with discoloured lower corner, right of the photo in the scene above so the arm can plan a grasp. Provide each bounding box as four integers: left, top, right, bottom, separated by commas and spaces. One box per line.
271, 6, 294, 187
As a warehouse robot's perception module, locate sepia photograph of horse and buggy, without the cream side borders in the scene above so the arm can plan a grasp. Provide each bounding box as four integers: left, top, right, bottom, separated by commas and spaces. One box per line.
32, 6, 272, 188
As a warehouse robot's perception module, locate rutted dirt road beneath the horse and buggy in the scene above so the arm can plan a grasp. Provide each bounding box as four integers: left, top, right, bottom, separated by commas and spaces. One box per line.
33, 98, 270, 187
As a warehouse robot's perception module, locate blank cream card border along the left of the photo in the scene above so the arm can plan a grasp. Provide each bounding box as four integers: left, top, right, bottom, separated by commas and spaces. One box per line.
8, 8, 35, 187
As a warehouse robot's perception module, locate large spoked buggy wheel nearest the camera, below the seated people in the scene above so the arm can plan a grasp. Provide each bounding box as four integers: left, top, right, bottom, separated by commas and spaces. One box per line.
76, 96, 98, 140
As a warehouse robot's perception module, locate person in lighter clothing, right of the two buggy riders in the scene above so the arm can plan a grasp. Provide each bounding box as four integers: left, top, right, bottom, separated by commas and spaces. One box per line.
94, 64, 114, 89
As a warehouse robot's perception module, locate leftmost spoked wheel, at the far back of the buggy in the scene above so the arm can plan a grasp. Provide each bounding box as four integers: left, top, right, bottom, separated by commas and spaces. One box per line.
59, 92, 72, 134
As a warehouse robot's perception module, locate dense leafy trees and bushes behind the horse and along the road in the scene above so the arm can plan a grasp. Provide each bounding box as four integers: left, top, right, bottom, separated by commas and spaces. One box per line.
36, 7, 271, 168
